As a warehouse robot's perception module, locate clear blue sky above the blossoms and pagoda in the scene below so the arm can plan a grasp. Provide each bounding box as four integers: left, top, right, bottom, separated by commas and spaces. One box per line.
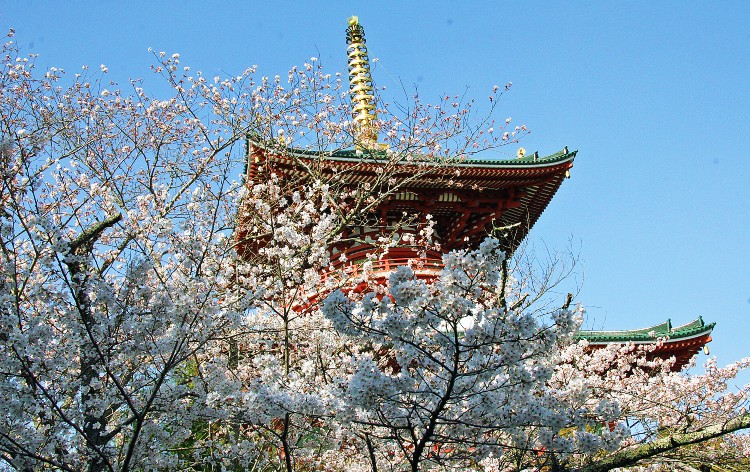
0, 0, 750, 380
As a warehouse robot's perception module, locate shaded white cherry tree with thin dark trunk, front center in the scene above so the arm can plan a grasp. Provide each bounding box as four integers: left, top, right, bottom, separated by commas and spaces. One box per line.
322, 239, 628, 471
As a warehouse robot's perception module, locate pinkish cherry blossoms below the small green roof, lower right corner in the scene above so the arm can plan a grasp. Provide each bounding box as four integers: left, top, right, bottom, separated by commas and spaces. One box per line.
550, 343, 750, 471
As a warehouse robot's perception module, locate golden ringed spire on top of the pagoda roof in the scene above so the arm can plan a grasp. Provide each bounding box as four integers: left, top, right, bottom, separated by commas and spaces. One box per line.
346, 16, 386, 149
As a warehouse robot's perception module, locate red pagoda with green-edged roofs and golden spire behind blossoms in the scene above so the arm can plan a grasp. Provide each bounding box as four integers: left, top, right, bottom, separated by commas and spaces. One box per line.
246, 17, 714, 371
